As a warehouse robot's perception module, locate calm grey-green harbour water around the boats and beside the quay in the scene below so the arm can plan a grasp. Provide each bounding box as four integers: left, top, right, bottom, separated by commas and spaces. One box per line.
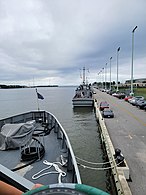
0, 87, 107, 193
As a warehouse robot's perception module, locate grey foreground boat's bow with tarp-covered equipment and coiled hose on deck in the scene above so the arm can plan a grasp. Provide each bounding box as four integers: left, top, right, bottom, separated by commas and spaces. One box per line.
0, 111, 107, 195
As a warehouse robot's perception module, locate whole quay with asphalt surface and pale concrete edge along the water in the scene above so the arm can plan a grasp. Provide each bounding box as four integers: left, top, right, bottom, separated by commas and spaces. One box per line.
94, 88, 146, 195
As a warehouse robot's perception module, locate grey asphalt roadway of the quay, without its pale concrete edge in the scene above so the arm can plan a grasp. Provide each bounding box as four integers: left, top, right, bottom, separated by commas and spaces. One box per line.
94, 89, 146, 195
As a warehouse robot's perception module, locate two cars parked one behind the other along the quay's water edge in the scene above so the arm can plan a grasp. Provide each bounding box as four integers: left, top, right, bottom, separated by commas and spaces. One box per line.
99, 101, 114, 118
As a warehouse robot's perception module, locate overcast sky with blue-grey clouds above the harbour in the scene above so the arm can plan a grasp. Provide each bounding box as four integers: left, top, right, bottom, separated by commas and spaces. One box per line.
0, 0, 146, 85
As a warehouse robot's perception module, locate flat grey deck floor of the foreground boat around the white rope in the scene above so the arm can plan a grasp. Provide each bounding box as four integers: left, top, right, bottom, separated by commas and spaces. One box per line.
0, 131, 68, 185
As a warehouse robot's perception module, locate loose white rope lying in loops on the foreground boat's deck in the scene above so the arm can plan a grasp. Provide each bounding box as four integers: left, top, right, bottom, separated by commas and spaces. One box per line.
32, 155, 67, 183
